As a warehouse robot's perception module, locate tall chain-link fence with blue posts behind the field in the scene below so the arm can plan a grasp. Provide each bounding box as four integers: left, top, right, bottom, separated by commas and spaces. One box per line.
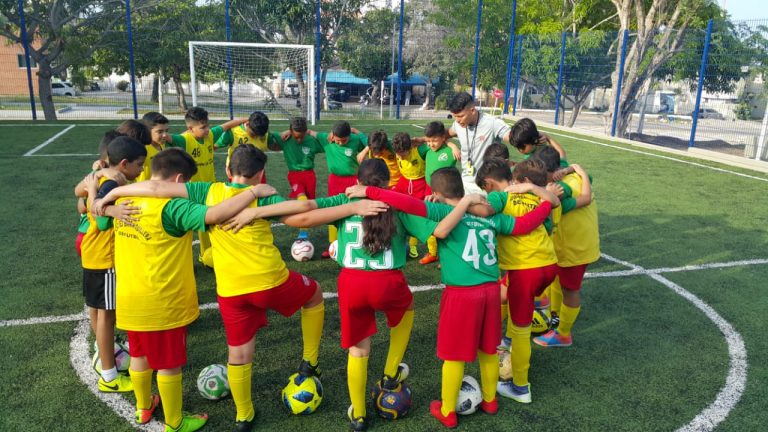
0, 0, 768, 159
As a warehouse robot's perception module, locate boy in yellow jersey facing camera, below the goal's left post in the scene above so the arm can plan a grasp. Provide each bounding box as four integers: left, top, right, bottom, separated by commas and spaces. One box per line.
168, 107, 244, 267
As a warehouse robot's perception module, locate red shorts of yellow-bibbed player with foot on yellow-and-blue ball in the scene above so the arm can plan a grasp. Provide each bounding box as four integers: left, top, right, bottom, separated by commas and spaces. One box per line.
218, 271, 317, 346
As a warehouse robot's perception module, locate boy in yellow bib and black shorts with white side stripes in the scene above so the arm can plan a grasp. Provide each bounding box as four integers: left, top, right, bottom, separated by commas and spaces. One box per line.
76, 136, 147, 392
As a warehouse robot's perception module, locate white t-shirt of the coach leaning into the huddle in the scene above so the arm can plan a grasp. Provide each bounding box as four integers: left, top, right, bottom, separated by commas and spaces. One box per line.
451, 112, 510, 193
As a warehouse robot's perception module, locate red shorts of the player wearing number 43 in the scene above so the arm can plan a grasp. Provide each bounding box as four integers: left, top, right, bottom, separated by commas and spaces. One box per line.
437, 282, 501, 362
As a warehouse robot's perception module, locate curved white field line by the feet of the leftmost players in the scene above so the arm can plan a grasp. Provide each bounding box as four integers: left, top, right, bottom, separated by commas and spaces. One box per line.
69, 320, 165, 432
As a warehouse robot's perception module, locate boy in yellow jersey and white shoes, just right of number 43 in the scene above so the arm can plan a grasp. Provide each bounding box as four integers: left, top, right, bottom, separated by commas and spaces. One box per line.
477, 159, 559, 403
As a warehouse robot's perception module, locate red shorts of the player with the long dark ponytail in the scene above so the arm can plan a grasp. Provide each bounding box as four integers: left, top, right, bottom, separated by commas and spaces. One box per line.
338, 268, 414, 349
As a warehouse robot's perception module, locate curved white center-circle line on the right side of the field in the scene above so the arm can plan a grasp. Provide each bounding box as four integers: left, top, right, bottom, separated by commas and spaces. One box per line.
602, 254, 747, 432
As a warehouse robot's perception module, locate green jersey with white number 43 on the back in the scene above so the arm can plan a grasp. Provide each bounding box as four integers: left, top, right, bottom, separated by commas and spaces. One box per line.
420, 202, 515, 286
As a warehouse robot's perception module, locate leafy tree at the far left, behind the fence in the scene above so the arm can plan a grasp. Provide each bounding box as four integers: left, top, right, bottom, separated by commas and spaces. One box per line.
0, 0, 152, 120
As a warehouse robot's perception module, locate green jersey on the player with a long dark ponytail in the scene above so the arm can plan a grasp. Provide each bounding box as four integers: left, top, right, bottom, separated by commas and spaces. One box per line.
317, 194, 437, 270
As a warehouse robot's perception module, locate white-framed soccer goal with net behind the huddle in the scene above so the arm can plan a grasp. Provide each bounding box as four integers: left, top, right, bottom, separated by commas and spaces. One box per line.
189, 41, 316, 124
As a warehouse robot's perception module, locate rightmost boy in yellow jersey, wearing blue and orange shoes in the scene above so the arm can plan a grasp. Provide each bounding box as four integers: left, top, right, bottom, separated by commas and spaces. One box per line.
533, 146, 600, 347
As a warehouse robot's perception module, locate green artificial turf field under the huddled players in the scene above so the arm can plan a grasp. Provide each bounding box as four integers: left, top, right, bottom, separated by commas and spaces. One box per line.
0, 120, 768, 431
